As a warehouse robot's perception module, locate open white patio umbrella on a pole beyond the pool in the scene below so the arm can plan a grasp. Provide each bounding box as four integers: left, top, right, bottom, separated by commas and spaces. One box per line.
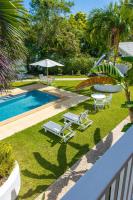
30, 59, 64, 78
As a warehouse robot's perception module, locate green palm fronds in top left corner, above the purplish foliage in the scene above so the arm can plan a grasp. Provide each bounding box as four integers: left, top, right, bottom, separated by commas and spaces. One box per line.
0, 0, 26, 57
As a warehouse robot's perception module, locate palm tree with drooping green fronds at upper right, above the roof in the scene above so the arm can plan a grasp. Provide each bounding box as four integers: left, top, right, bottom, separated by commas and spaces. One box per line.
88, 1, 132, 63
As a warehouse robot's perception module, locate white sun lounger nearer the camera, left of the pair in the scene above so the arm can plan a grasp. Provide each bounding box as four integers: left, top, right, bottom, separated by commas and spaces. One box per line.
43, 121, 76, 142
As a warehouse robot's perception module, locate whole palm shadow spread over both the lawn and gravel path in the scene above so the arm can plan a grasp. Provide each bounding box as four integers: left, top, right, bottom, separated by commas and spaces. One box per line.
21, 128, 112, 199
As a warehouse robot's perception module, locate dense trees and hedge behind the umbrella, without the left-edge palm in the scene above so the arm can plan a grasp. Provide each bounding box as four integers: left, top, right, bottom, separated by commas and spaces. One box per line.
26, 0, 133, 74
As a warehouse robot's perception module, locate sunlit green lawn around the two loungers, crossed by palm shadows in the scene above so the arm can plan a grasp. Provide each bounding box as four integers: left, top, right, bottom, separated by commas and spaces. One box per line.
0, 81, 131, 199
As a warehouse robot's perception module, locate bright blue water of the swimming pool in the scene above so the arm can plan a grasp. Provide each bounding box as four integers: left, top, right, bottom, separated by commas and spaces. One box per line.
0, 90, 59, 121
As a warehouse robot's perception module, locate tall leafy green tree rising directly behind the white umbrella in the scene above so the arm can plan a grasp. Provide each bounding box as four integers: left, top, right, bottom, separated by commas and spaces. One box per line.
28, 0, 77, 59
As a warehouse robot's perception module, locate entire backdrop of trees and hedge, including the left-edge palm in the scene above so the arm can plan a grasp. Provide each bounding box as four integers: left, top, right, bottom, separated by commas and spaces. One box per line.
0, 0, 133, 81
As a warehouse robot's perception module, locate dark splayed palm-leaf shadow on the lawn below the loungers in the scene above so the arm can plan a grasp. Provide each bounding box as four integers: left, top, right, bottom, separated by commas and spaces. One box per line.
21, 142, 89, 199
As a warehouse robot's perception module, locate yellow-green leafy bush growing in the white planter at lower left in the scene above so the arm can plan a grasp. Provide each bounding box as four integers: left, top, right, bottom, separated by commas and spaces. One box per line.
0, 144, 15, 179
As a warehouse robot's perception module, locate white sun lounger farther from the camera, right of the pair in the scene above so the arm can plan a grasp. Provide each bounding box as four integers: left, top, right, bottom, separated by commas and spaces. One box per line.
63, 110, 93, 130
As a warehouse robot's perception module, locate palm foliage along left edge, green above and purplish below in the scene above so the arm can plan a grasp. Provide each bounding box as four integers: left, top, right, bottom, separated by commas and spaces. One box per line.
0, 0, 26, 89
